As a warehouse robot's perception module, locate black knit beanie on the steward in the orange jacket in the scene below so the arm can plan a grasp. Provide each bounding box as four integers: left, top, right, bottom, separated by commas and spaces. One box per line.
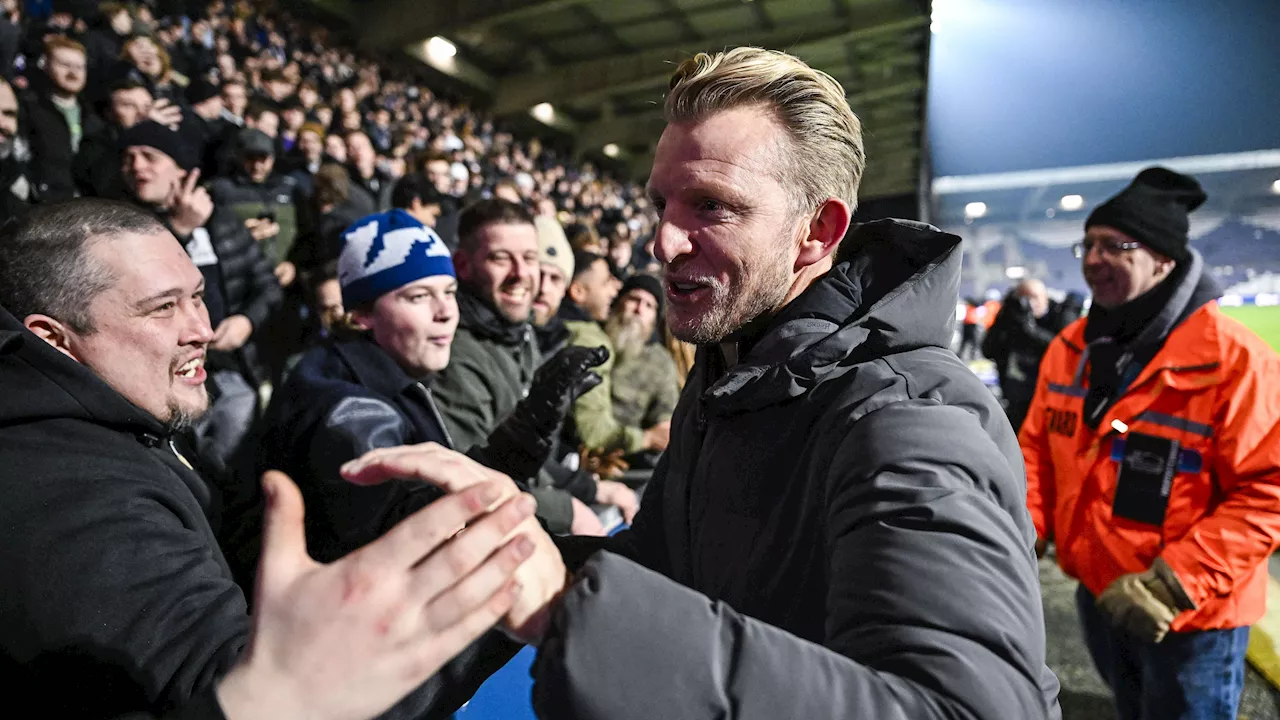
1084, 168, 1208, 263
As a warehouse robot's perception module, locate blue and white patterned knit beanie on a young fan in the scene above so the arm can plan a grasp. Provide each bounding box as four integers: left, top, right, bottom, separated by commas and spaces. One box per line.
338, 210, 456, 307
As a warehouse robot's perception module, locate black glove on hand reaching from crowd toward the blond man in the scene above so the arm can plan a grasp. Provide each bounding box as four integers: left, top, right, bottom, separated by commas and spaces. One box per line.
470, 346, 609, 482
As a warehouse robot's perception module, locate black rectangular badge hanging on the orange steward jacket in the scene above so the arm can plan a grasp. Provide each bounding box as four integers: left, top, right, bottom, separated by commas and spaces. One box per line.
1111, 433, 1181, 527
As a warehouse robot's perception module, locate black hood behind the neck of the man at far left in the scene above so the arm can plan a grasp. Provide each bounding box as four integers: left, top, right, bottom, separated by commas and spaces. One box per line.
0, 301, 168, 430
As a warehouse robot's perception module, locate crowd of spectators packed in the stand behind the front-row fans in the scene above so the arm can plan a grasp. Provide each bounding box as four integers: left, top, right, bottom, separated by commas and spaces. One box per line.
0, 0, 692, 499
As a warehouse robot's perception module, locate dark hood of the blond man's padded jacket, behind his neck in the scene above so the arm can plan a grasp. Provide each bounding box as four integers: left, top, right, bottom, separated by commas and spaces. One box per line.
703, 215, 961, 414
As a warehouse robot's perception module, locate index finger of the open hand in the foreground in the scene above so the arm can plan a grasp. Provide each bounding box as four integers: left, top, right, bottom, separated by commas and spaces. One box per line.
357, 483, 522, 568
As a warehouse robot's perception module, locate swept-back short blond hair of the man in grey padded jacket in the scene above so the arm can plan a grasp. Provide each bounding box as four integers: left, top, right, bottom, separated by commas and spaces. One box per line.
663, 47, 867, 210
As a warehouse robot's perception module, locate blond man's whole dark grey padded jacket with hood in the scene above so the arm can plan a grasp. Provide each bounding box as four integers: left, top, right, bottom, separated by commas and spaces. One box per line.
534, 220, 1060, 720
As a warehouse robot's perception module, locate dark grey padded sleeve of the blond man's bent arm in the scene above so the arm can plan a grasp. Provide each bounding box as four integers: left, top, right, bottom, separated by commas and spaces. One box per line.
534, 404, 1059, 720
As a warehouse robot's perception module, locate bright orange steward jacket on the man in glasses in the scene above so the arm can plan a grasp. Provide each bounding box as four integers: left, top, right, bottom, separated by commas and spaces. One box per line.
1019, 301, 1280, 630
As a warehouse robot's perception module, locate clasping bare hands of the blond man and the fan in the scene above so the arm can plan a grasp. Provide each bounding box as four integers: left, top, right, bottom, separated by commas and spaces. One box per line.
218, 443, 568, 720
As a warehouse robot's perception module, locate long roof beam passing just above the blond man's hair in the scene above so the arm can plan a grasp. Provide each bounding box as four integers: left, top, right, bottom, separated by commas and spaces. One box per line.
494, 9, 928, 115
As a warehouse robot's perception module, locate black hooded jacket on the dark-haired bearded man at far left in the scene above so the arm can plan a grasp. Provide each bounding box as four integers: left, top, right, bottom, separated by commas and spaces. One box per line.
0, 302, 250, 717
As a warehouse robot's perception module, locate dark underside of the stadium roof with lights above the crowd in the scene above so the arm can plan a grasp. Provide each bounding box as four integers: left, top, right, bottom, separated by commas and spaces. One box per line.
330, 0, 929, 197
